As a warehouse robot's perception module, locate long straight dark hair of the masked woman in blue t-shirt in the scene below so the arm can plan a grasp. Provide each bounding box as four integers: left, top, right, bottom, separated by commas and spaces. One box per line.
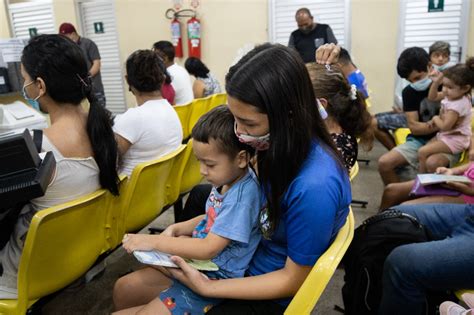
226, 43, 343, 231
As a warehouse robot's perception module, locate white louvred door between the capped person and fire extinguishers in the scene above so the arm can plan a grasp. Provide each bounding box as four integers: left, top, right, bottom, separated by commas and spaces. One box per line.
78, 0, 127, 113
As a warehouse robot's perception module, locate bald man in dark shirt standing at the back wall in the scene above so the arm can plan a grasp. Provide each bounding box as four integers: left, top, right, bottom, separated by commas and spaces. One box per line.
288, 8, 337, 63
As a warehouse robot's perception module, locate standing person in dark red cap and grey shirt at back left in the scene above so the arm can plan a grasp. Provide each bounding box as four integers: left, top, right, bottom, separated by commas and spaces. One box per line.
59, 23, 105, 107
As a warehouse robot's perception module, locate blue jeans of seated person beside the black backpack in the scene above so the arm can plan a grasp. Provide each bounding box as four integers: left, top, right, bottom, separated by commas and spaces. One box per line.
379, 204, 474, 315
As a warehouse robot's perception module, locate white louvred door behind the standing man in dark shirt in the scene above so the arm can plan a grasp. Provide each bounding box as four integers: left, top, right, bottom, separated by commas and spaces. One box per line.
268, 0, 350, 50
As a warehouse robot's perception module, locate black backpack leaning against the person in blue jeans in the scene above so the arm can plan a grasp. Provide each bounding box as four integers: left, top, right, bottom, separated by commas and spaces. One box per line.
342, 210, 431, 315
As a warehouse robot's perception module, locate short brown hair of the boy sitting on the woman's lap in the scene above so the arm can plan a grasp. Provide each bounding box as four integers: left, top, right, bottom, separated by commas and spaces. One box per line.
191, 105, 255, 158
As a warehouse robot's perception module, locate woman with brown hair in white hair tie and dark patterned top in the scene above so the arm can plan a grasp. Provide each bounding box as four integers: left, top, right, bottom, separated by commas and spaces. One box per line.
306, 63, 373, 171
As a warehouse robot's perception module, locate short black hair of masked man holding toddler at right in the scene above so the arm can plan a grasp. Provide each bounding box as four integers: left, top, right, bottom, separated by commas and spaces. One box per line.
397, 47, 430, 79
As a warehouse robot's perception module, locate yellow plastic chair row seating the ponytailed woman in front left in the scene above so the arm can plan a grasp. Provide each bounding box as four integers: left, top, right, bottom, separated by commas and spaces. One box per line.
0, 141, 202, 314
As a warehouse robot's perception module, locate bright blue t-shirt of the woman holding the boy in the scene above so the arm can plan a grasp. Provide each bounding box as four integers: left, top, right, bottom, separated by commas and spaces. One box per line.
247, 142, 352, 305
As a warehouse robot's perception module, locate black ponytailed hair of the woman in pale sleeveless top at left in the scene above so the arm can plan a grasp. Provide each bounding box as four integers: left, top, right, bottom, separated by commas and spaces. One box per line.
21, 35, 119, 195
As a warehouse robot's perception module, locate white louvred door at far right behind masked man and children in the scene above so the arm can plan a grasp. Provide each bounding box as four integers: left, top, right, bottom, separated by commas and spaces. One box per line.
395, 0, 470, 107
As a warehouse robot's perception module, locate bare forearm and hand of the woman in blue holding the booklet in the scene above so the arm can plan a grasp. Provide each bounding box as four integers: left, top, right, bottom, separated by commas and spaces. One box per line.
169, 257, 312, 300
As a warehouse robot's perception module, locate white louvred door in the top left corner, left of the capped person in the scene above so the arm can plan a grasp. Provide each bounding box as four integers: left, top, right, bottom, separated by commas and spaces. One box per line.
8, 0, 57, 39
